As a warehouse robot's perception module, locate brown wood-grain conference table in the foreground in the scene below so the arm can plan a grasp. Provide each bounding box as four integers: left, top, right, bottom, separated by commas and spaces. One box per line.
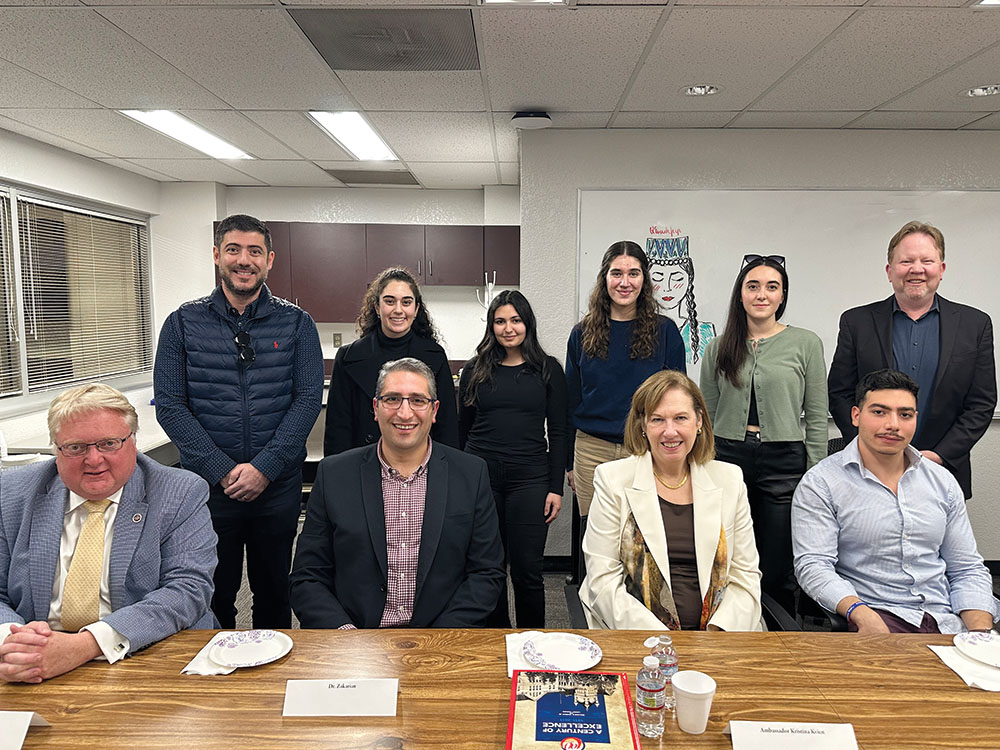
0, 630, 1000, 750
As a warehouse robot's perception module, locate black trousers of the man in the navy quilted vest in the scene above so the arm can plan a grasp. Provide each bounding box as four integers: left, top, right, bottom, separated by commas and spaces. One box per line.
208, 472, 302, 630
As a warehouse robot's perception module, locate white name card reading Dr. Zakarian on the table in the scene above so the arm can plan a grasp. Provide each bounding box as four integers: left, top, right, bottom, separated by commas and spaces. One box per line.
281, 678, 399, 716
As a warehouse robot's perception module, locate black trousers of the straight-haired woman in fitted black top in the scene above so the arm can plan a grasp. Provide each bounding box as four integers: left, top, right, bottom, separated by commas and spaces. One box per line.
485, 458, 549, 629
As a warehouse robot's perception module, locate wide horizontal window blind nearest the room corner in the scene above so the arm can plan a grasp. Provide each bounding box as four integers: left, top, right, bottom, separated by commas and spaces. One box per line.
17, 197, 153, 392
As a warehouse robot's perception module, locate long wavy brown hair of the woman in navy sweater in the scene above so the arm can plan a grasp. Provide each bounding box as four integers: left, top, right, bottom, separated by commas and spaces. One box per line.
580, 240, 660, 359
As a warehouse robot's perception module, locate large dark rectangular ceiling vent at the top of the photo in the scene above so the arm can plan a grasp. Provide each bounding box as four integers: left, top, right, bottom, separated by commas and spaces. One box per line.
288, 8, 479, 70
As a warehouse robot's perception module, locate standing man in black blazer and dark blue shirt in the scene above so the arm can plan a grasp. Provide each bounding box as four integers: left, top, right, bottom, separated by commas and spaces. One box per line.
828, 221, 997, 499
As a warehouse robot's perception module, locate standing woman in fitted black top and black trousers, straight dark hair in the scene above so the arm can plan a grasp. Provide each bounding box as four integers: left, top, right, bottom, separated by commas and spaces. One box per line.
458, 291, 566, 628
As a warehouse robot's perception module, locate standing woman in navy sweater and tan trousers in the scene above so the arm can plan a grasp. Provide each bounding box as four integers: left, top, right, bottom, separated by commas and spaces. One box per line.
566, 240, 687, 518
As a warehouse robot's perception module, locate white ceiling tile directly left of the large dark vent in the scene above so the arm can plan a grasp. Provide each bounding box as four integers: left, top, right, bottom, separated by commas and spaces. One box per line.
99, 7, 353, 109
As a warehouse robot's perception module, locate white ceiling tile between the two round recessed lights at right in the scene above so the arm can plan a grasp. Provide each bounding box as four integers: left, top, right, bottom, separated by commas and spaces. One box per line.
753, 8, 1000, 111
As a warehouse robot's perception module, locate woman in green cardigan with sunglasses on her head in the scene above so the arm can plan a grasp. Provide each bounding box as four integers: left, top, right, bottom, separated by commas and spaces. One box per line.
701, 255, 827, 611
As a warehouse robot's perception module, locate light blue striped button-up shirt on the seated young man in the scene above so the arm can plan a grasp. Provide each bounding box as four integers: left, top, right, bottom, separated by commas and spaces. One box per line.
792, 438, 1000, 633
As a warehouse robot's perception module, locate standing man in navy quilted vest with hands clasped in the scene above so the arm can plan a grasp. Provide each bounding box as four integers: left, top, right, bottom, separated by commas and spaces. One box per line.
153, 214, 323, 628
